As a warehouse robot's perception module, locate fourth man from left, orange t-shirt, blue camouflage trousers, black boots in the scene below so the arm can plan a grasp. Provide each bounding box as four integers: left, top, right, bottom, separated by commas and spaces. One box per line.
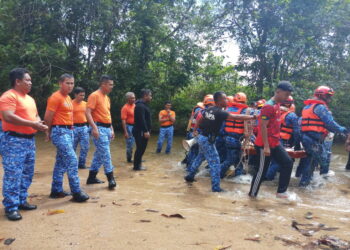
86, 75, 117, 189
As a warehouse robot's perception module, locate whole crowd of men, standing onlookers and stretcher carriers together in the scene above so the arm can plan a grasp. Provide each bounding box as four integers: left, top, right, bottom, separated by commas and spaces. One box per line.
0, 68, 348, 220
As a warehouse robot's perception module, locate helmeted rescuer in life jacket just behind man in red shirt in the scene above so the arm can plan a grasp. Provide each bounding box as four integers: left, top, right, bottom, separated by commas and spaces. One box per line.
265, 96, 300, 180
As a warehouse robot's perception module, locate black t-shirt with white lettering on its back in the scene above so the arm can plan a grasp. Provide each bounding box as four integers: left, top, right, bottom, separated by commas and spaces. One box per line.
199, 106, 228, 136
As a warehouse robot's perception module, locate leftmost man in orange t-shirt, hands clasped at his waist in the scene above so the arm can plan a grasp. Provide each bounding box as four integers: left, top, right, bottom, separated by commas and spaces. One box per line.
0, 68, 47, 220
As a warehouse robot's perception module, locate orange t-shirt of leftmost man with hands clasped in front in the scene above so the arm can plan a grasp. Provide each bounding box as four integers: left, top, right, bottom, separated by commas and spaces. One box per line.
0, 89, 38, 134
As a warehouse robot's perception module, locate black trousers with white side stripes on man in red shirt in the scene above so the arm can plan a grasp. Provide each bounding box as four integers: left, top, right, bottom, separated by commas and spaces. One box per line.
249, 145, 293, 197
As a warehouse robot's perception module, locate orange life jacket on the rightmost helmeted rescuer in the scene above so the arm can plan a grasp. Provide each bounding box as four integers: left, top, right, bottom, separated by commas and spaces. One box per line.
301, 99, 328, 134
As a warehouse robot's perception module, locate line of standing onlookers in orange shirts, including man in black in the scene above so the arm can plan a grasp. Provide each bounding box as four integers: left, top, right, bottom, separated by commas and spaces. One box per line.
0, 68, 175, 221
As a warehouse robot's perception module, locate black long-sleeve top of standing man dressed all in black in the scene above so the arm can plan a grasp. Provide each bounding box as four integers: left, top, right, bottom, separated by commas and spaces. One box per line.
134, 100, 151, 133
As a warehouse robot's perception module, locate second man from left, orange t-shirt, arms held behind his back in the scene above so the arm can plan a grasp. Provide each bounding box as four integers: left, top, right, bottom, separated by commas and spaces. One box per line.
45, 74, 89, 202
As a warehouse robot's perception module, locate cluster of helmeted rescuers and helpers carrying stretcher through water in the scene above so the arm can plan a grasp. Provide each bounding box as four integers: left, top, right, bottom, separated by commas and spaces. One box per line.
182, 81, 348, 198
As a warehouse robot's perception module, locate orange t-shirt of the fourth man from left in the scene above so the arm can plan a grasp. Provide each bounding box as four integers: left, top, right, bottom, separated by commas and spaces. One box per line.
87, 90, 112, 123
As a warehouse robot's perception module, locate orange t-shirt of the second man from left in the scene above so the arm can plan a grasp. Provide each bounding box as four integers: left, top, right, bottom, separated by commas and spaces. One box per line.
46, 90, 73, 125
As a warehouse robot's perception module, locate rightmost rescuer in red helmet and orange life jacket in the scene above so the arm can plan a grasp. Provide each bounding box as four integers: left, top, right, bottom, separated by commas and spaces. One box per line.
297, 86, 348, 186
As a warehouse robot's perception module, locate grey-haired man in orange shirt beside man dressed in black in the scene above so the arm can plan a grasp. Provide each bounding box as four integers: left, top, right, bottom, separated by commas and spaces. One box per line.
121, 92, 135, 163
